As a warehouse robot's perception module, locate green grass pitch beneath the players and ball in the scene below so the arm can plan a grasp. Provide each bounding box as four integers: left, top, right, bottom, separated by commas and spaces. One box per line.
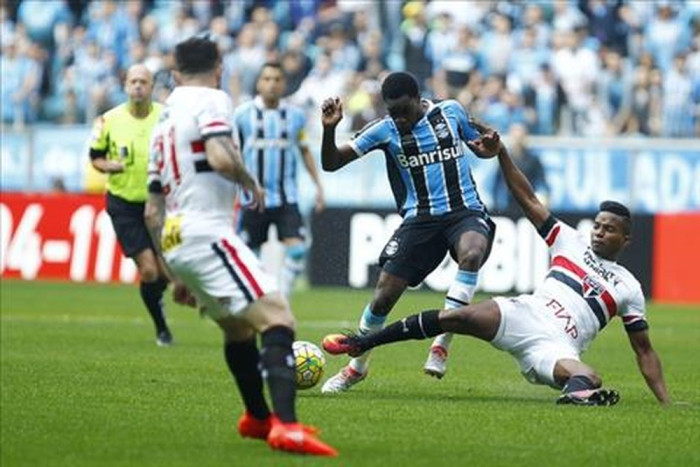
0, 280, 700, 467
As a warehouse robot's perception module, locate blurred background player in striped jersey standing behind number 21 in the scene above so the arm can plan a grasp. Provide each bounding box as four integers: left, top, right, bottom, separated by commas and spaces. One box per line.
234, 62, 324, 297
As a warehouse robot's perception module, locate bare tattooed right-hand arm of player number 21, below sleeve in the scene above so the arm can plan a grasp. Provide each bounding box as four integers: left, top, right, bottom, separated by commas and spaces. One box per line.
204, 136, 265, 211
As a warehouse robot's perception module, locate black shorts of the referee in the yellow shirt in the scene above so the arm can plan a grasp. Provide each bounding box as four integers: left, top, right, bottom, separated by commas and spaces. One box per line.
107, 192, 153, 258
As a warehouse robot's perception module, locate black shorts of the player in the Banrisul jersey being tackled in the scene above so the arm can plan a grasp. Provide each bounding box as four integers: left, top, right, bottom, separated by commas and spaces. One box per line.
379, 211, 496, 287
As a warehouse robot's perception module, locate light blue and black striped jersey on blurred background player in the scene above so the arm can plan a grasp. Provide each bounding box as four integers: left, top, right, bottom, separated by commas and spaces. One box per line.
234, 96, 307, 208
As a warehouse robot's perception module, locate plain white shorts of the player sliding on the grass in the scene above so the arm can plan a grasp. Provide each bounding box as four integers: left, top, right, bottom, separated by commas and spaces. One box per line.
491, 295, 580, 389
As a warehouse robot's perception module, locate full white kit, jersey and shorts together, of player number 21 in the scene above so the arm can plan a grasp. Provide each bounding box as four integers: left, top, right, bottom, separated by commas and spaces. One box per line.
149, 86, 277, 319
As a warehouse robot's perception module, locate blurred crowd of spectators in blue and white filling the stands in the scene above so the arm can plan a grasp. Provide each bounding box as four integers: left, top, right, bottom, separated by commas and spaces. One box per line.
0, 0, 700, 137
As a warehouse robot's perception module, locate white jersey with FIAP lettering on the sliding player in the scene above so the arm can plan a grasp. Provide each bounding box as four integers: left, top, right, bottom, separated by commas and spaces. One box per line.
533, 217, 648, 351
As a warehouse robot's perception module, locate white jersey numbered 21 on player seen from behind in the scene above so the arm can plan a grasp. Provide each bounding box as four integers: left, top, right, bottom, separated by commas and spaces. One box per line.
149, 86, 237, 236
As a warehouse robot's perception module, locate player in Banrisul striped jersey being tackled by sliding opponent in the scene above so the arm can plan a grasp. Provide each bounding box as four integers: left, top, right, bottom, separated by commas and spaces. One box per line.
321, 72, 498, 393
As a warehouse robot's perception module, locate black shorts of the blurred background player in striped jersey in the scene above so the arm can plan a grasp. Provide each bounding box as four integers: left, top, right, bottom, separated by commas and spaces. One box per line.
241, 204, 304, 249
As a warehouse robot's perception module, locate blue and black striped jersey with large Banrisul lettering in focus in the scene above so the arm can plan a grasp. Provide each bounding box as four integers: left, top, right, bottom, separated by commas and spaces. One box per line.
350, 100, 485, 218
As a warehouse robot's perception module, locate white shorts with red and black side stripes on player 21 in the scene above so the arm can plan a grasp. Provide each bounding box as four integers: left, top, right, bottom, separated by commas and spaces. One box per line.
163, 229, 278, 320
